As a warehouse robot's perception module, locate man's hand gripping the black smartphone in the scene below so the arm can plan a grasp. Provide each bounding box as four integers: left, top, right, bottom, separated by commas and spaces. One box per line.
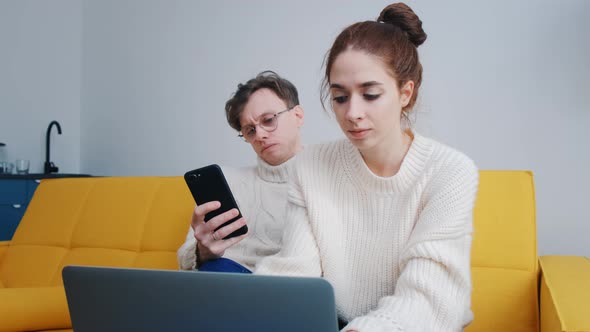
191, 201, 248, 263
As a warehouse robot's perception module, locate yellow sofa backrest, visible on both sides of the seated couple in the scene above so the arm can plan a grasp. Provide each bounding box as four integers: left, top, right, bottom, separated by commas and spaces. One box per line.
0, 171, 538, 332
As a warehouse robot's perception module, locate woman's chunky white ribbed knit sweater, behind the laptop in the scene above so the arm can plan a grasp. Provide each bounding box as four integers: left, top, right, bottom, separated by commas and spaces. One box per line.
255, 134, 478, 332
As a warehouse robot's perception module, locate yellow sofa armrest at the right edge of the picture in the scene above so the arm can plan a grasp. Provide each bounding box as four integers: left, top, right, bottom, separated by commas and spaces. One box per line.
539, 256, 590, 332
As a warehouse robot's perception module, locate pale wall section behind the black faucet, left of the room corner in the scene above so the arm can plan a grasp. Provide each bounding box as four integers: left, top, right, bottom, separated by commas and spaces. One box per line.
0, 0, 82, 173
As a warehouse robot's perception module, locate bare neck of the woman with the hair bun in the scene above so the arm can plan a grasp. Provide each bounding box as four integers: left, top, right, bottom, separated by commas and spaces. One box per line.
361, 129, 414, 177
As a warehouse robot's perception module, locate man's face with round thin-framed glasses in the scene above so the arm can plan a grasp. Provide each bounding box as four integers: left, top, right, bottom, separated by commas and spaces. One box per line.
240, 89, 303, 166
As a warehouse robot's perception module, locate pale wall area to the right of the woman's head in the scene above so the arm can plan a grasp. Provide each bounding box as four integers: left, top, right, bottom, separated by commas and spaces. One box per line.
420, 0, 590, 256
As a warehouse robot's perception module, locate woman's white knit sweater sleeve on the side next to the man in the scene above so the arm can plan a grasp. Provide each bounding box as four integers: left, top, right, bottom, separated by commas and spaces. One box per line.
254, 172, 322, 277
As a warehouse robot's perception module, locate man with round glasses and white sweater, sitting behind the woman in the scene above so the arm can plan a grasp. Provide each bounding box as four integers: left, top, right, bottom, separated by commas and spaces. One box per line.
177, 71, 304, 273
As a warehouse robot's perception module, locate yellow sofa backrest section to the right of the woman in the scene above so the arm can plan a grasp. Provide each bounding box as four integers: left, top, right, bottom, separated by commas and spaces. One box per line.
466, 171, 539, 332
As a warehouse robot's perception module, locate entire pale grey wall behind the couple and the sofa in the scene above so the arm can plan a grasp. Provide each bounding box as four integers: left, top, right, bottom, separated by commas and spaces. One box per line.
0, 0, 590, 256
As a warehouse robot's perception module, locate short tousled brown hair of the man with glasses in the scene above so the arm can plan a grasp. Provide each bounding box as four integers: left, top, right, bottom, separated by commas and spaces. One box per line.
225, 70, 299, 131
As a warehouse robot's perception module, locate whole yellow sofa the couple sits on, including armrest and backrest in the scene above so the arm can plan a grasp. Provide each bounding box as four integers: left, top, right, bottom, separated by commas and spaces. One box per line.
0, 171, 590, 332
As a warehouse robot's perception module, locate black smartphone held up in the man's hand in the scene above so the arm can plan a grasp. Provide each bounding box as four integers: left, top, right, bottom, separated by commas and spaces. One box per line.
184, 164, 248, 239
